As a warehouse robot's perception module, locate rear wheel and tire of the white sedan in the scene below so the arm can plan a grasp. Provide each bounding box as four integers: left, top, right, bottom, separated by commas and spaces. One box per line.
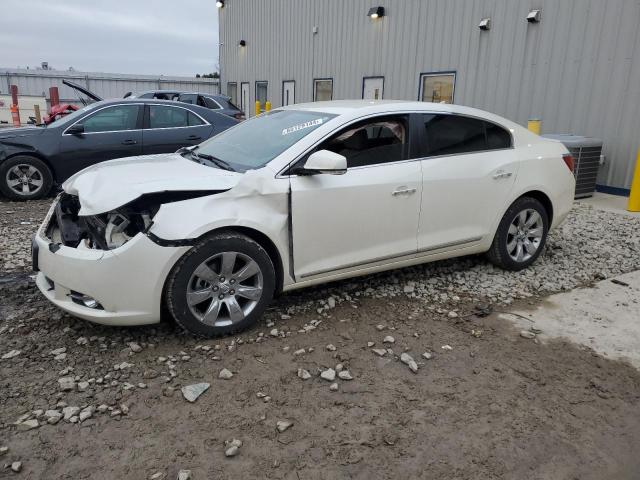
487, 197, 549, 271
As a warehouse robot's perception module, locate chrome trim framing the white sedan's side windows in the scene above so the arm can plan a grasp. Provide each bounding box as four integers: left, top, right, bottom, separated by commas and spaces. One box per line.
275, 110, 515, 178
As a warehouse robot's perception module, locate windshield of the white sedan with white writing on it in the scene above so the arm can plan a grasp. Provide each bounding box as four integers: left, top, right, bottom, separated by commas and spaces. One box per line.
195, 110, 335, 172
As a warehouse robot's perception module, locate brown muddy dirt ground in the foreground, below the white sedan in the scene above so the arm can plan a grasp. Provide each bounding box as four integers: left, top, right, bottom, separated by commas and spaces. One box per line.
0, 280, 640, 480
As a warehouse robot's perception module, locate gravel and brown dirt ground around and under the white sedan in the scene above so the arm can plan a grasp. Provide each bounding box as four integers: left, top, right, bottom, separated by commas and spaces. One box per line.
0, 200, 640, 480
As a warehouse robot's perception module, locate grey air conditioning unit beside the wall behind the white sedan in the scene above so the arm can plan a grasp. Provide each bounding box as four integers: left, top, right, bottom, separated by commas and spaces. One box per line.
543, 134, 602, 198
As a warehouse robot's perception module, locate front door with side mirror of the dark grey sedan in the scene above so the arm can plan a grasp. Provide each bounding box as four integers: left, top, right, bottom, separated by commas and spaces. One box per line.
53, 103, 143, 172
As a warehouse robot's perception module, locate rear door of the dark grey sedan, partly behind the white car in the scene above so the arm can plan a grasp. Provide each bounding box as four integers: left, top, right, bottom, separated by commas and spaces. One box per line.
142, 104, 213, 155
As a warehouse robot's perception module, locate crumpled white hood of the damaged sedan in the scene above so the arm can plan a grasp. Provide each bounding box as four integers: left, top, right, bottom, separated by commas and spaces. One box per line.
62, 153, 243, 216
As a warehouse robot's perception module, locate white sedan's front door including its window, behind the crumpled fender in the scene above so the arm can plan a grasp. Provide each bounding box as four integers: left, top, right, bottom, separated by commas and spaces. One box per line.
291, 115, 422, 281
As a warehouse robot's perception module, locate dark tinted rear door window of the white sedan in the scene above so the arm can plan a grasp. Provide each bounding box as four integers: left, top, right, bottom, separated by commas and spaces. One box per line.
422, 114, 511, 157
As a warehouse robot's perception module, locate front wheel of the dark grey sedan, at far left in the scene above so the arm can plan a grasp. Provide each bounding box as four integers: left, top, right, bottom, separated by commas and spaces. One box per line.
0, 156, 53, 200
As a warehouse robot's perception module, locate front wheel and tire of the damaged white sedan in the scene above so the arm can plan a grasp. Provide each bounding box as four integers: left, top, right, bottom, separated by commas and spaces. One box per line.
165, 232, 276, 338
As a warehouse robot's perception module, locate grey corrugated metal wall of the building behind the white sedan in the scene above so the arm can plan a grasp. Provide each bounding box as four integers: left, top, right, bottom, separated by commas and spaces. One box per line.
220, 0, 640, 188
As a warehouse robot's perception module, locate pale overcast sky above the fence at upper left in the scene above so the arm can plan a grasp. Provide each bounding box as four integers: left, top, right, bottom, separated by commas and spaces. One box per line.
0, 0, 218, 76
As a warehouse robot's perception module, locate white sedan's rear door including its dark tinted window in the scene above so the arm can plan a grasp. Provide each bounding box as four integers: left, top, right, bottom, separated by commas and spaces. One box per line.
418, 115, 519, 252
